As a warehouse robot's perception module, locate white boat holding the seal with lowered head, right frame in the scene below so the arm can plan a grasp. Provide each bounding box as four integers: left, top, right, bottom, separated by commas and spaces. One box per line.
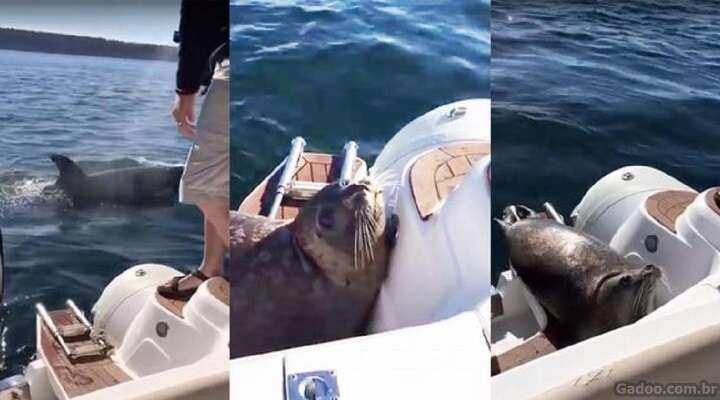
490, 166, 720, 400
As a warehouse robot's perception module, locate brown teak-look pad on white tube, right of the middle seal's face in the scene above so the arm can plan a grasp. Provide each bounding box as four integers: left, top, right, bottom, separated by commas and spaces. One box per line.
410, 143, 490, 219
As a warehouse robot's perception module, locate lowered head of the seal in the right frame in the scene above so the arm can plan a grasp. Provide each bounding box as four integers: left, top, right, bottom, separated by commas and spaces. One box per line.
595, 265, 662, 326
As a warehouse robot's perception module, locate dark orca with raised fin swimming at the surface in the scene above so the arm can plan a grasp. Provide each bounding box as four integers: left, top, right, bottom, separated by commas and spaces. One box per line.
50, 154, 183, 207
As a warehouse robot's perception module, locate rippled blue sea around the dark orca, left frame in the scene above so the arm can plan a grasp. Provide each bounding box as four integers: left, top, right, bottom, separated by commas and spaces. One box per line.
0, 50, 202, 375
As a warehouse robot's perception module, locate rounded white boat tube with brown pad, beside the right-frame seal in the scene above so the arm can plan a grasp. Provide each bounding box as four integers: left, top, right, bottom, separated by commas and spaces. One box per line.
572, 166, 720, 304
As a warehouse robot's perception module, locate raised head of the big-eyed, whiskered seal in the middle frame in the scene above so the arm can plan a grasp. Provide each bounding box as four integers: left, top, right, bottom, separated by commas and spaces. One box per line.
291, 181, 387, 286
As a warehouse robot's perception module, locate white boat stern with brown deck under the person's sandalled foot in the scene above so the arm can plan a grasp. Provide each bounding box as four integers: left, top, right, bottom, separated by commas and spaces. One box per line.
0, 239, 230, 400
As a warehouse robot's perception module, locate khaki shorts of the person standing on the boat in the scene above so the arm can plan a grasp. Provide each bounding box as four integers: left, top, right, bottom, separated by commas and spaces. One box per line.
180, 61, 230, 204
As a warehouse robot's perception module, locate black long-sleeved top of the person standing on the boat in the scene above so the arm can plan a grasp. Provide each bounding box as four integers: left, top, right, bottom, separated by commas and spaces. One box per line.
176, 0, 230, 94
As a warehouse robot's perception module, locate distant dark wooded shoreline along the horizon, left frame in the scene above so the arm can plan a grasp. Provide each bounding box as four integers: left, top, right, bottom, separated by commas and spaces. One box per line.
0, 28, 177, 62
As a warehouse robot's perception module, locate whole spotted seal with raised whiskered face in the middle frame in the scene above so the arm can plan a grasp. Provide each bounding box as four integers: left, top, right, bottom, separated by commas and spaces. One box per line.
230, 182, 396, 357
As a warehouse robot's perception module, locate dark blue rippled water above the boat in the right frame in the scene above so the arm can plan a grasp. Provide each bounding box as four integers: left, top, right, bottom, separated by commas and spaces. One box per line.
492, 0, 720, 278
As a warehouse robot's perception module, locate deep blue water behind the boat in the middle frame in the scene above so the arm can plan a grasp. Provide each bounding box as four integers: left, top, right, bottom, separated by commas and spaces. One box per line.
231, 0, 490, 206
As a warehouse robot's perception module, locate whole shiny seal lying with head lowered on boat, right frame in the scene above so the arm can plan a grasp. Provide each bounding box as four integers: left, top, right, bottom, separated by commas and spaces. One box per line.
498, 206, 661, 341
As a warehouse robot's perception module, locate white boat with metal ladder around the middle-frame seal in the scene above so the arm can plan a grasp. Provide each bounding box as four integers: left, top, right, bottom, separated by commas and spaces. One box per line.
230, 100, 490, 400
